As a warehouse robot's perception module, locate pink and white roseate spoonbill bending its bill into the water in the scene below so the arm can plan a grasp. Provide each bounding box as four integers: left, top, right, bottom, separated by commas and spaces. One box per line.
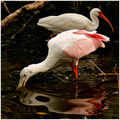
17, 29, 109, 89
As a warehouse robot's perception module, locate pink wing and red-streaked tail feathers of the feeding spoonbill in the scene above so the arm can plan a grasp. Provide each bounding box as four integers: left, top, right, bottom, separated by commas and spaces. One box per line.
63, 30, 109, 58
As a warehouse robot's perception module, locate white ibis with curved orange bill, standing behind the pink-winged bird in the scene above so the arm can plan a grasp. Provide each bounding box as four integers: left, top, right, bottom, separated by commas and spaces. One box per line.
37, 8, 114, 34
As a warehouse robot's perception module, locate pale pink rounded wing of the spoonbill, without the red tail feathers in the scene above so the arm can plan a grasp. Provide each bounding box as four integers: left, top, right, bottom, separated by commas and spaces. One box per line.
63, 36, 96, 58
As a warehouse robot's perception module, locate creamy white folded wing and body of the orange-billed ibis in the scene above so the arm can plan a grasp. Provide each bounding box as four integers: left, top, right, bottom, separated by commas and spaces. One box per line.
37, 13, 91, 34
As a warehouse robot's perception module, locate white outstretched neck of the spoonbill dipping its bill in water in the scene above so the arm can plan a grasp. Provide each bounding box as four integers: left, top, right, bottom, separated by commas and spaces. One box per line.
28, 57, 57, 76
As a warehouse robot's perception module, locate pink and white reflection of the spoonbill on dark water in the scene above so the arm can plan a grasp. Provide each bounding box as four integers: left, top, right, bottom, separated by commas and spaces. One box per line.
20, 82, 108, 115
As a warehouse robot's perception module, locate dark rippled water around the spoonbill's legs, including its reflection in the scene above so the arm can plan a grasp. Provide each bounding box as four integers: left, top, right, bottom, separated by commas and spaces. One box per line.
1, 31, 119, 119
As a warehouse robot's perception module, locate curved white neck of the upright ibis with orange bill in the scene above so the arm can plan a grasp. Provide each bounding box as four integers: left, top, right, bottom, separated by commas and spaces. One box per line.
90, 13, 99, 31
